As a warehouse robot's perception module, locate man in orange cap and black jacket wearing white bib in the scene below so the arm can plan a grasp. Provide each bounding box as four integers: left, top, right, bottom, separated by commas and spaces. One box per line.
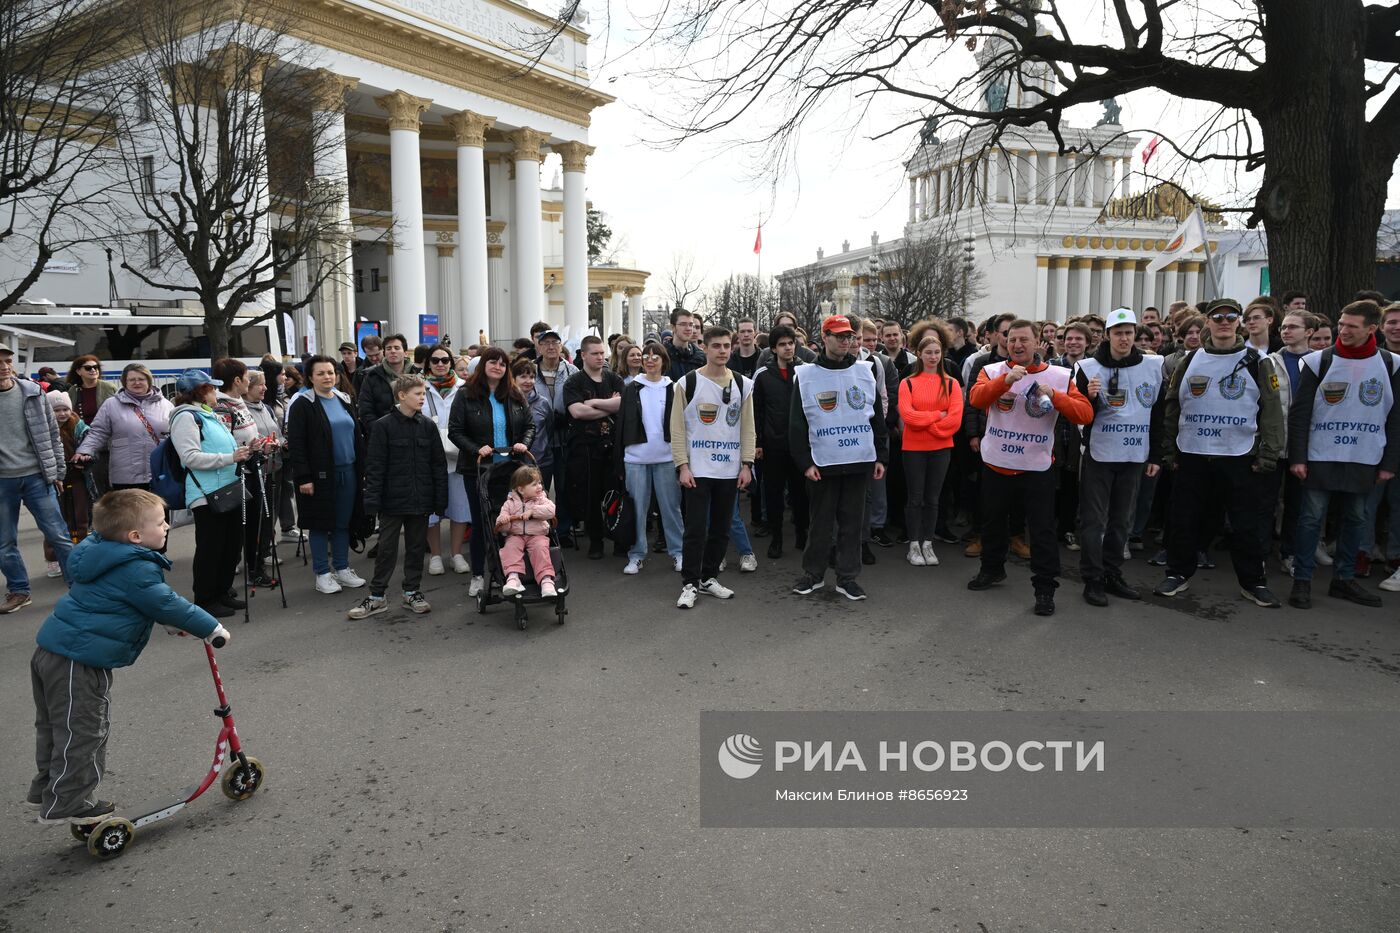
788, 315, 889, 600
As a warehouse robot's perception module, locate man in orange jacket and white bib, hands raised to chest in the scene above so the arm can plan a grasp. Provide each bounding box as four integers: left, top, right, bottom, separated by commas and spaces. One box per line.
967, 321, 1095, 615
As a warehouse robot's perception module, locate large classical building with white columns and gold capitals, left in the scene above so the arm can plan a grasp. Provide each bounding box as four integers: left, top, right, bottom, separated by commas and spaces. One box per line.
12, 0, 647, 349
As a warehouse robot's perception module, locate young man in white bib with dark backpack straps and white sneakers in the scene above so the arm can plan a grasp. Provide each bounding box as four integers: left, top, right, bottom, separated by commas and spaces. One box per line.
671, 328, 756, 609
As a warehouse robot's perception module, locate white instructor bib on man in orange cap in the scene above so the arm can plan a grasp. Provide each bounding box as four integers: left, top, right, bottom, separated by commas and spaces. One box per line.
792, 361, 876, 467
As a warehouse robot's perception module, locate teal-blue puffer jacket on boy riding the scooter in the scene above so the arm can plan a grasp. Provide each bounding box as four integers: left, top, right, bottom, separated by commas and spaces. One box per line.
36, 534, 218, 668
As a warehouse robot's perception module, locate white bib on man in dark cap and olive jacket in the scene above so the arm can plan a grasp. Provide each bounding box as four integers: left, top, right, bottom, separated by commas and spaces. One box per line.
1176, 349, 1259, 457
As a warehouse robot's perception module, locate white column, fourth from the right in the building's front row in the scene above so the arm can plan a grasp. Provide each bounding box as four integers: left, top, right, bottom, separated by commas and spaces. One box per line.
374, 91, 433, 337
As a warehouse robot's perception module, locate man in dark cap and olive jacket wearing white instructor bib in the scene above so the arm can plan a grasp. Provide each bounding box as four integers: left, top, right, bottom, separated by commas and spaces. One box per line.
1154, 298, 1284, 609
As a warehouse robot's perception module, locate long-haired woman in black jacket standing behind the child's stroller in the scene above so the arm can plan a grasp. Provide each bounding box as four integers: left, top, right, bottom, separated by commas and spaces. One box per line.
447, 346, 535, 595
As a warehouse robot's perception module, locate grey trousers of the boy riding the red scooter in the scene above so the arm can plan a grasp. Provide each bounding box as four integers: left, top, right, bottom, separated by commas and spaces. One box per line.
28, 647, 112, 820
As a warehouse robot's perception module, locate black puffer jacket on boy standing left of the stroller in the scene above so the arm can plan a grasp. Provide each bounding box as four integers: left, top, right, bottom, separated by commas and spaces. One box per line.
364, 406, 447, 516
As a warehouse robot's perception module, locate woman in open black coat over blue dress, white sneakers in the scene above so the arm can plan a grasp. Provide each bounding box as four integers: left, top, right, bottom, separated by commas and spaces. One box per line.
287, 356, 365, 593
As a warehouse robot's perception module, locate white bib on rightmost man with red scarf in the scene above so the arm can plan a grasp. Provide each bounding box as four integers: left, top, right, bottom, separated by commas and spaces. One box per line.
1298, 350, 1394, 467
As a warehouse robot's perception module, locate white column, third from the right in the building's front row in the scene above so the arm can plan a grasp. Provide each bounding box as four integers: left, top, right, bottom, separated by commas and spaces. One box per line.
438, 111, 496, 346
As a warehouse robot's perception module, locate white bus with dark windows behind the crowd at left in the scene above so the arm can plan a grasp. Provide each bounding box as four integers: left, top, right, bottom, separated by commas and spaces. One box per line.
0, 304, 284, 388
